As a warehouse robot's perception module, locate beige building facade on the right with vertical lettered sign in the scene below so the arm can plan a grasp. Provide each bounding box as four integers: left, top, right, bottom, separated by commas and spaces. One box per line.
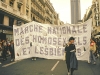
83, 0, 100, 37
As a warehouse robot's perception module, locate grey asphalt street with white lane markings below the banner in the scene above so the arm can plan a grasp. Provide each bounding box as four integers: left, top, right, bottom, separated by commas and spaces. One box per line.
0, 57, 100, 75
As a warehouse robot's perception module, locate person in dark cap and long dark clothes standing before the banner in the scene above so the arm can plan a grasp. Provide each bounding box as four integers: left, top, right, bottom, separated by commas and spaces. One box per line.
65, 37, 78, 75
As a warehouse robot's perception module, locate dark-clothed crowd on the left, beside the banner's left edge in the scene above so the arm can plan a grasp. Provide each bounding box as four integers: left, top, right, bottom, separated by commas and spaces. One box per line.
0, 38, 15, 64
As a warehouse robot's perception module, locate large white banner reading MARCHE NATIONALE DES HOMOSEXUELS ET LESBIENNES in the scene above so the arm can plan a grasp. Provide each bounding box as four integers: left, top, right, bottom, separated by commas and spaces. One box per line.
13, 19, 92, 60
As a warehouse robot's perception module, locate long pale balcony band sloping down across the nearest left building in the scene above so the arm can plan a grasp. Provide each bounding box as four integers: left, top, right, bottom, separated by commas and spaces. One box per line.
0, 1, 31, 21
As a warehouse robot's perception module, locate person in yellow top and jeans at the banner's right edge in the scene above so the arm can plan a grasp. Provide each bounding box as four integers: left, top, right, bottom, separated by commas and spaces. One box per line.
89, 38, 96, 64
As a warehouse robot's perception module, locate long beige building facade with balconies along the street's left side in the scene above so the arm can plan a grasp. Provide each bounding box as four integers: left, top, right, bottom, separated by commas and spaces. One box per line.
0, 0, 60, 39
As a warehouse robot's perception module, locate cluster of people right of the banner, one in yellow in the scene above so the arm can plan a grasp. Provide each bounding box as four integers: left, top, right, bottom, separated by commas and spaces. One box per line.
88, 38, 100, 64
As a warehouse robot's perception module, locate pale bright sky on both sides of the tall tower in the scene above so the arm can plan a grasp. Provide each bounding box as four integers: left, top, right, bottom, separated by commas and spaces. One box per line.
50, 0, 92, 23
